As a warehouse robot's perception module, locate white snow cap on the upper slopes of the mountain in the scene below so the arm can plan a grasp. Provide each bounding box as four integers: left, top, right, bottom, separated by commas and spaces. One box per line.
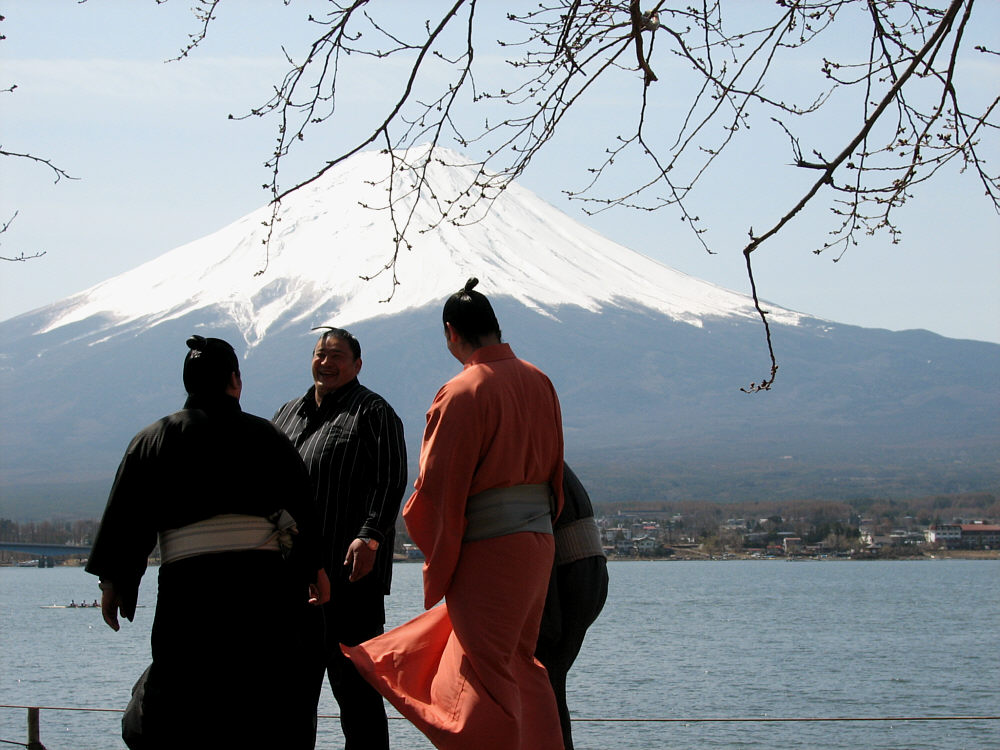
44, 149, 801, 347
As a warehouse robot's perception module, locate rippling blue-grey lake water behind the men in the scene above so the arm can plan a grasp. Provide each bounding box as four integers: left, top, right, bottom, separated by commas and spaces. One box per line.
0, 560, 1000, 750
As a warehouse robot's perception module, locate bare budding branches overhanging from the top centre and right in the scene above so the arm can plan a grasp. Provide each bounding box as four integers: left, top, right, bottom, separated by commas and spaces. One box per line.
164, 0, 1000, 392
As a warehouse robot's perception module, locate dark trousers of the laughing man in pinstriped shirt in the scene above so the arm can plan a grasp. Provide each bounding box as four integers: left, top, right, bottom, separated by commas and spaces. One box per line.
313, 584, 389, 750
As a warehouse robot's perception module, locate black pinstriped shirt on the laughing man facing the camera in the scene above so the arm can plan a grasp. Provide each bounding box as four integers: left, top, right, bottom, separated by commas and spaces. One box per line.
271, 378, 406, 594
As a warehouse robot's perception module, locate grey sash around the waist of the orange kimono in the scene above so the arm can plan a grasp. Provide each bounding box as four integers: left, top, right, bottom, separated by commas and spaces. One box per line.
462, 483, 552, 542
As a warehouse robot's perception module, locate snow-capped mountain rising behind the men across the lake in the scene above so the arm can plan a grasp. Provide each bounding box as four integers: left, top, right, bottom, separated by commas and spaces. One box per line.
0, 151, 1000, 520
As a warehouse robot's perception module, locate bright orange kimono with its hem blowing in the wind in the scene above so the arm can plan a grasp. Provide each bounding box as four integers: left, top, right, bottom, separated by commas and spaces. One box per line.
342, 344, 563, 750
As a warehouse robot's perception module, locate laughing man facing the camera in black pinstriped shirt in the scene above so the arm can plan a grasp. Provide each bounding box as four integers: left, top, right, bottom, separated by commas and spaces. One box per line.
272, 328, 406, 750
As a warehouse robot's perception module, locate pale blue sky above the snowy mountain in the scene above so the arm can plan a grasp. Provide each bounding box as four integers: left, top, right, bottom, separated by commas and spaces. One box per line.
0, 0, 1000, 342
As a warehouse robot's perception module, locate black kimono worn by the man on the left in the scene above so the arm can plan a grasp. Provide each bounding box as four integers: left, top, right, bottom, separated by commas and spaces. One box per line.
87, 396, 321, 748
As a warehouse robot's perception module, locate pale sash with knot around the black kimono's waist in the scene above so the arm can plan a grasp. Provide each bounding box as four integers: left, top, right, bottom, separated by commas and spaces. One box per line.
159, 513, 291, 565
